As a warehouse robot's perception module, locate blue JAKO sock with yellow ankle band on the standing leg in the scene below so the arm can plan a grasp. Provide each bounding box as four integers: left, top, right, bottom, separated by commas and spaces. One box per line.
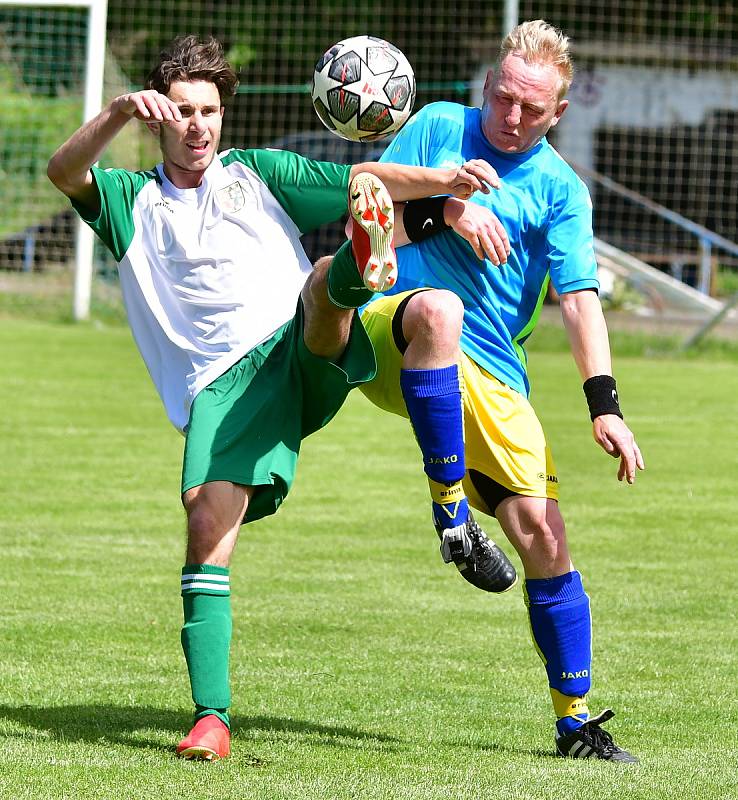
525, 571, 592, 735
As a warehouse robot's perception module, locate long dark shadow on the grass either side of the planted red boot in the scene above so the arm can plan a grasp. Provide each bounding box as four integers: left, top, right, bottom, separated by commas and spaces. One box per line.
0, 704, 399, 753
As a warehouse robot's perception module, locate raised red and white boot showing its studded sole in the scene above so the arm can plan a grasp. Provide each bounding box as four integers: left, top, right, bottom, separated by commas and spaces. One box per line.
349, 172, 397, 292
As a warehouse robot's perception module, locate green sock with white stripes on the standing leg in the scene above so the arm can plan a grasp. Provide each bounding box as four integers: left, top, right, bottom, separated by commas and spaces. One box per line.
182, 564, 232, 725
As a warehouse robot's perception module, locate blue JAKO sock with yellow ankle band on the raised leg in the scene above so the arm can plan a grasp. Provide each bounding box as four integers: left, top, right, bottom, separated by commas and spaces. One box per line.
400, 364, 469, 528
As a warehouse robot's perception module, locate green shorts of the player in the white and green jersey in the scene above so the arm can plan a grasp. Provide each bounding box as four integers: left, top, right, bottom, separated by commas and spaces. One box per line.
182, 301, 376, 522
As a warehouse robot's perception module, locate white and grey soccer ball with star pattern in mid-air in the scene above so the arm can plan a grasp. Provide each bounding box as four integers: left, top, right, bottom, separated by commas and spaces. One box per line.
312, 36, 415, 142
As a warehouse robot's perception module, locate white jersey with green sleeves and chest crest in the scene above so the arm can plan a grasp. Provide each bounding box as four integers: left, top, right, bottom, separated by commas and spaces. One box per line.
72, 150, 350, 430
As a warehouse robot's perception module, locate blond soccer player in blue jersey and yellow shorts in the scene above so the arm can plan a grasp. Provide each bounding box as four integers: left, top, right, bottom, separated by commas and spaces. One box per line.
362, 20, 644, 762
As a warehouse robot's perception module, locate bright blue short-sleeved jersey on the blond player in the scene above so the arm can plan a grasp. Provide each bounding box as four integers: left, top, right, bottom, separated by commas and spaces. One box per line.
380, 103, 599, 396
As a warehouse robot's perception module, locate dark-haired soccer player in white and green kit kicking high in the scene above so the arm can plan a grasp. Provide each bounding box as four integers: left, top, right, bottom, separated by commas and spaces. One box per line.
48, 36, 490, 759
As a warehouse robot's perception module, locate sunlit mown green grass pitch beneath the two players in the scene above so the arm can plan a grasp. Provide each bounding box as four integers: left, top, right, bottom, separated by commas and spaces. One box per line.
0, 320, 738, 800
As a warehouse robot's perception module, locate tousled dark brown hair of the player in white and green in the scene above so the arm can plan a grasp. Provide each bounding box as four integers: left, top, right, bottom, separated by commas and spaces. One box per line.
145, 35, 238, 103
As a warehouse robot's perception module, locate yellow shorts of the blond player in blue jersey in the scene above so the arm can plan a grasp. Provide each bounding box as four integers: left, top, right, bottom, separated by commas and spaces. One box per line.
360, 292, 559, 514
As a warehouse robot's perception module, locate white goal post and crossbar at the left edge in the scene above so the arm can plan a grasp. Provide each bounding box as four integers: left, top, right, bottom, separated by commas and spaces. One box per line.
0, 0, 108, 320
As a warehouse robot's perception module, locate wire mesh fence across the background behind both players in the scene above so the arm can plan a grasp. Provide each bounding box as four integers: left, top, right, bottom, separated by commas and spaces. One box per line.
0, 0, 738, 300
